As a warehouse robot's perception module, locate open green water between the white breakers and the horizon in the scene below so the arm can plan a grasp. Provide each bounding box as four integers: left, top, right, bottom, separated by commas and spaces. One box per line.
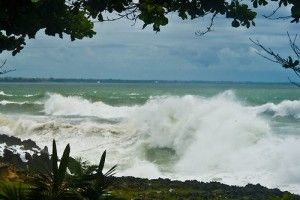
0, 83, 300, 114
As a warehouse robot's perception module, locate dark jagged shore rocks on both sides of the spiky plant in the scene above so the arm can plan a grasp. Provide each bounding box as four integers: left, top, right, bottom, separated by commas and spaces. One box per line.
0, 134, 300, 200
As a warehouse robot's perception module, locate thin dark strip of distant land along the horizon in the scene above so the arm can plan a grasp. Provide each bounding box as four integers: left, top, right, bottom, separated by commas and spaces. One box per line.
0, 77, 291, 85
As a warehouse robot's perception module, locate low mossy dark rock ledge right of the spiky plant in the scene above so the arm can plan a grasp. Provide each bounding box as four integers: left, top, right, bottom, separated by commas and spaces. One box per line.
110, 177, 300, 200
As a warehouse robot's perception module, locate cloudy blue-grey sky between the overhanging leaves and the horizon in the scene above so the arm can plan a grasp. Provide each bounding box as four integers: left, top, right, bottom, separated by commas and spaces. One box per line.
1, 2, 300, 82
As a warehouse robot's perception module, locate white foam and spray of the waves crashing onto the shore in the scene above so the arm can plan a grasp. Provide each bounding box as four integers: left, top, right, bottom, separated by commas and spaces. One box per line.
0, 91, 300, 193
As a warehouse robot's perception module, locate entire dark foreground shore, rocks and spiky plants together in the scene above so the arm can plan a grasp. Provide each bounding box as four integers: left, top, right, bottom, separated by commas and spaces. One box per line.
0, 135, 300, 200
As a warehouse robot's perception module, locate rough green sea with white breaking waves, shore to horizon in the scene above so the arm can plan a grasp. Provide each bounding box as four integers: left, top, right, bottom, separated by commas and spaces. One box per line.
0, 82, 300, 194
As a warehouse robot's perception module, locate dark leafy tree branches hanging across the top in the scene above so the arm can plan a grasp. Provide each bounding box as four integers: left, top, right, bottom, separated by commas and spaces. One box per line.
0, 0, 300, 55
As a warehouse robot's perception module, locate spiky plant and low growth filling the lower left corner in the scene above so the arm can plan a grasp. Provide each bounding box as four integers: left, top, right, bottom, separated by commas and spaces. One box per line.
0, 140, 116, 200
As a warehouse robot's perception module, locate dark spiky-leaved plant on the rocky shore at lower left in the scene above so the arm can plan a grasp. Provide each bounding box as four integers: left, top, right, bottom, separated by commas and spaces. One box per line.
22, 140, 116, 200
